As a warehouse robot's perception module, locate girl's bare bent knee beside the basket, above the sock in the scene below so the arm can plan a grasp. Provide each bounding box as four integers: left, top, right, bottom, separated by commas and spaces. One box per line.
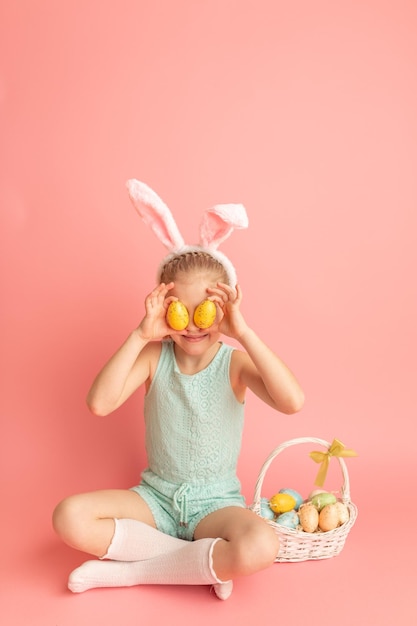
194, 507, 279, 580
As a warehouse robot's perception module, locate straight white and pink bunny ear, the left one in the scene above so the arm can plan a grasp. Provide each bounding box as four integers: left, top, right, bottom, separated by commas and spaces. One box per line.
126, 178, 184, 251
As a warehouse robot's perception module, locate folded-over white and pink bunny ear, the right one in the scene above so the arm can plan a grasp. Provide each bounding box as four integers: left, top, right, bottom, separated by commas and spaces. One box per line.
200, 204, 249, 250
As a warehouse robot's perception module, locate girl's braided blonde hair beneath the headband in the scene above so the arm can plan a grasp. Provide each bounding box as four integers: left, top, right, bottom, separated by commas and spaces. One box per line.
160, 250, 230, 285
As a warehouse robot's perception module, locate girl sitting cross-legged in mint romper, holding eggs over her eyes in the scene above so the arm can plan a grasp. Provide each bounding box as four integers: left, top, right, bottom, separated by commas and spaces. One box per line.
53, 181, 303, 599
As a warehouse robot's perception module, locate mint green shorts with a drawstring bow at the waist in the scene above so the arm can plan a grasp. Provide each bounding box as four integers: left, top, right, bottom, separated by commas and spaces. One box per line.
131, 469, 246, 541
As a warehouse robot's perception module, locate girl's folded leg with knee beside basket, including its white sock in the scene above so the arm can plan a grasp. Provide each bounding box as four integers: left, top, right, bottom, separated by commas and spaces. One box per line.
65, 507, 279, 600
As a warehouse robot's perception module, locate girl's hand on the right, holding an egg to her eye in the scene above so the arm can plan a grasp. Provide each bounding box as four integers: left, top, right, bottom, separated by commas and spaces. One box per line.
207, 283, 248, 340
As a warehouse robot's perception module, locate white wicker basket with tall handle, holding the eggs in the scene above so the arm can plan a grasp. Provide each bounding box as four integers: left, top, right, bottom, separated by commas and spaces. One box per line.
249, 437, 358, 563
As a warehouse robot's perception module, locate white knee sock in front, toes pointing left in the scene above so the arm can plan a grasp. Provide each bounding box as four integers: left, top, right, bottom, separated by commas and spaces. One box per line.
68, 539, 231, 599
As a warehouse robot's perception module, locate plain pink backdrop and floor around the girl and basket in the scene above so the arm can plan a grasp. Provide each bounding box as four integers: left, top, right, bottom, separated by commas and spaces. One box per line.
0, 0, 417, 626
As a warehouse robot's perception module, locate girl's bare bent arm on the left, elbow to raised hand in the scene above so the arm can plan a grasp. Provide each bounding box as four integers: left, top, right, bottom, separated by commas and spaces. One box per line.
87, 283, 173, 415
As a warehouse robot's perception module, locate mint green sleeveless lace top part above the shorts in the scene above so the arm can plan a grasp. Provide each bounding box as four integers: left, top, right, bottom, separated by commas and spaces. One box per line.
144, 341, 244, 483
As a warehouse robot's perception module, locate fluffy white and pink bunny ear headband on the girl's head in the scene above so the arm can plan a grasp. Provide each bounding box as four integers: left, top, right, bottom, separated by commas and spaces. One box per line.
126, 178, 248, 287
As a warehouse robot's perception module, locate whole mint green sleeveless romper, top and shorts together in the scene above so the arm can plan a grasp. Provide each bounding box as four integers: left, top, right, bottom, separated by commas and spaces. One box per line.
132, 340, 246, 540
